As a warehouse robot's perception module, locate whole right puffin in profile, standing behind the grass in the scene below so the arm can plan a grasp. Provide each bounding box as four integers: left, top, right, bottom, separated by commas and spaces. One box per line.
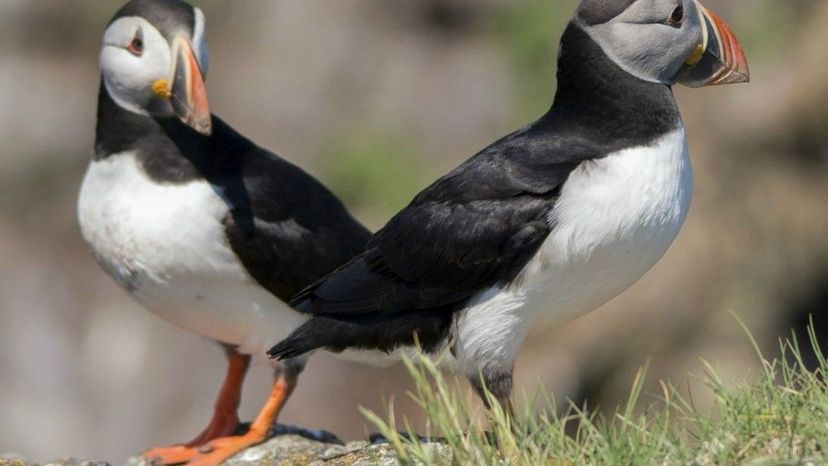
269, 0, 750, 413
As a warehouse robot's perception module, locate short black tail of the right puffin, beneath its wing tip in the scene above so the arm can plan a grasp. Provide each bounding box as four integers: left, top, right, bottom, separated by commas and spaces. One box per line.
267, 309, 452, 360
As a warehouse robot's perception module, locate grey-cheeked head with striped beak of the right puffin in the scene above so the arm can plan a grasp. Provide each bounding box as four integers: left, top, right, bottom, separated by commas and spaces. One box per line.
573, 0, 750, 87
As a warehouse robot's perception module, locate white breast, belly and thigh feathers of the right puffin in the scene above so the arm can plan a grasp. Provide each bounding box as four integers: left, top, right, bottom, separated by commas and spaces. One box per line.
455, 128, 693, 370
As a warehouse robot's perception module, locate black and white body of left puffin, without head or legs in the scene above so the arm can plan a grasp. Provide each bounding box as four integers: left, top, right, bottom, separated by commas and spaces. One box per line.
78, 86, 368, 354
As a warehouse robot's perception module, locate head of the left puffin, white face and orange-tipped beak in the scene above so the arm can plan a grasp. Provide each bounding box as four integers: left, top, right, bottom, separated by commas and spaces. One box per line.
100, 0, 211, 134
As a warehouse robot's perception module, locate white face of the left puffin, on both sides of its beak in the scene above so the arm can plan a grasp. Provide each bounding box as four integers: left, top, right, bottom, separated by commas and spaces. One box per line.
100, 8, 208, 116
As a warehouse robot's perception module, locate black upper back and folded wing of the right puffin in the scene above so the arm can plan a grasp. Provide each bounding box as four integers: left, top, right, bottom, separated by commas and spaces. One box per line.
294, 120, 596, 315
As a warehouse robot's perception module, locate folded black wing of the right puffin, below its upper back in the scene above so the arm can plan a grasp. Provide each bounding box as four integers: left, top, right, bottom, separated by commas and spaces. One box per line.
297, 187, 555, 314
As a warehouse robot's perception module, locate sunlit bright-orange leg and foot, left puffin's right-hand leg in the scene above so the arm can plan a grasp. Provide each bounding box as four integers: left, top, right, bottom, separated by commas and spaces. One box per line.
187, 365, 298, 466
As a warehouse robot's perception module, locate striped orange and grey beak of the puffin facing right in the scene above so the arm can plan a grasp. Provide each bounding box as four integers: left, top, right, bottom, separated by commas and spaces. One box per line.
677, 0, 750, 87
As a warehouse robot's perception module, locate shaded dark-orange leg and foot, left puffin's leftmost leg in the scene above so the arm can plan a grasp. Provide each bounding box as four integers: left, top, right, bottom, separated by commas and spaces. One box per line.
142, 348, 250, 464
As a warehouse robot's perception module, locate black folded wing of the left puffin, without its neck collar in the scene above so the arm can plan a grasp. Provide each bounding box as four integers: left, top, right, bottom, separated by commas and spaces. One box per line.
199, 118, 370, 302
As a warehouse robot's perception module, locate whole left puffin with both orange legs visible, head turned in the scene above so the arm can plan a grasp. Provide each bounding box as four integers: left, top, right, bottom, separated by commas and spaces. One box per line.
77, 0, 370, 465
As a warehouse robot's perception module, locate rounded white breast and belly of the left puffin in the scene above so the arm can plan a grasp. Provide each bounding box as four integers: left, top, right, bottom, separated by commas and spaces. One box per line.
78, 153, 304, 353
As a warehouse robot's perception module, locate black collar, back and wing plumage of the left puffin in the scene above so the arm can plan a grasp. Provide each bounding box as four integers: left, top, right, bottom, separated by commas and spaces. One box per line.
95, 84, 370, 302
